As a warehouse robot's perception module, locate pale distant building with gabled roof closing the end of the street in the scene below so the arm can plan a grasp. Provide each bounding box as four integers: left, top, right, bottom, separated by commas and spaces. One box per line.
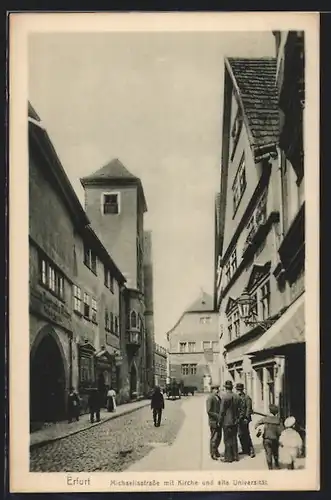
167, 292, 219, 392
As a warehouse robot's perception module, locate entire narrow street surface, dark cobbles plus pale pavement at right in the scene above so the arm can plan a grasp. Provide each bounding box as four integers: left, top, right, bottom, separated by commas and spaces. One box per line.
30, 394, 304, 472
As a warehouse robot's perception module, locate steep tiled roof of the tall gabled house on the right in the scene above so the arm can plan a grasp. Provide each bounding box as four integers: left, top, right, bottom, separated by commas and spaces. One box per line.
225, 57, 279, 160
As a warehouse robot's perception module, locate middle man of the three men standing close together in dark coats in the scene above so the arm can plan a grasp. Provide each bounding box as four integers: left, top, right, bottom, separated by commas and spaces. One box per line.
220, 380, 239, 462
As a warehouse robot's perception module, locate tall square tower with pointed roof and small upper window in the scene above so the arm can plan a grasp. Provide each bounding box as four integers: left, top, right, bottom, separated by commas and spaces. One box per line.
81, 159, 153, 398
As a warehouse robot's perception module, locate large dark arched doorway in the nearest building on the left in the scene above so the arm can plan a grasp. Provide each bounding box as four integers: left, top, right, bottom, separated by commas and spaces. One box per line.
30, 334, 66, 422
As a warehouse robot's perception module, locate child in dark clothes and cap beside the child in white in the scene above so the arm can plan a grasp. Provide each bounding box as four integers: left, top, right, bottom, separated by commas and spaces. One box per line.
255, 405, 283, 469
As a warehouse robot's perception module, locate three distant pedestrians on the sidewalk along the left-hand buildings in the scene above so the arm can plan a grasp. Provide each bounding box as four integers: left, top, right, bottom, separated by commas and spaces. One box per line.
68, 387, 116, 424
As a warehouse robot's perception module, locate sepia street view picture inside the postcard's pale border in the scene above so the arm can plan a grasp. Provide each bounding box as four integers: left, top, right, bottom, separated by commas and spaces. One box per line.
9, 10, 318, 491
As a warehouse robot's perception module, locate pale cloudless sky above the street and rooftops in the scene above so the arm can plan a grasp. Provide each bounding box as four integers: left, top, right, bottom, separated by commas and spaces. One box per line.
28, 32, 275, 346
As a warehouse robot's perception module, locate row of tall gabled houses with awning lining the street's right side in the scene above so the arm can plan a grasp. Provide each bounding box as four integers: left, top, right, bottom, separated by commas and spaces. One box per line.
215, 34, 305, 434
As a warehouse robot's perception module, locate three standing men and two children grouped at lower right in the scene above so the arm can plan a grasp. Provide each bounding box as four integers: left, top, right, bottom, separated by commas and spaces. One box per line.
207, 380, 303, 469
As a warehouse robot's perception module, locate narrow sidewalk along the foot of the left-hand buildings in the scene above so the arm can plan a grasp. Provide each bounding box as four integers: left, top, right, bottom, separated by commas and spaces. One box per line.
30, 399, 151, 449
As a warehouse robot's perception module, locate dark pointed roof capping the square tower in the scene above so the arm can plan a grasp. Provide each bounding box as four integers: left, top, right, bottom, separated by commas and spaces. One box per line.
80, 158, 147, 212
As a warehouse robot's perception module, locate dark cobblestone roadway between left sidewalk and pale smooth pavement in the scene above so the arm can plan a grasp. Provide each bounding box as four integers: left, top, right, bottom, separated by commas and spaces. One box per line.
30, 400, 184, 472
